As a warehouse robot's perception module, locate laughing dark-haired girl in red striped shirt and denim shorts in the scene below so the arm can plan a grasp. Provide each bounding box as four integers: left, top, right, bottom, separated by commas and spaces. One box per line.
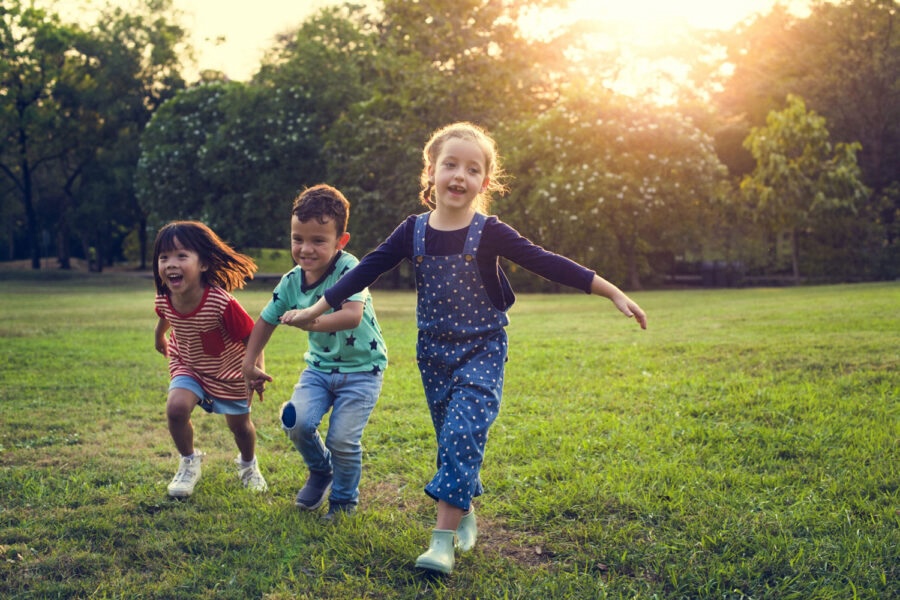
153, 221, 268, 498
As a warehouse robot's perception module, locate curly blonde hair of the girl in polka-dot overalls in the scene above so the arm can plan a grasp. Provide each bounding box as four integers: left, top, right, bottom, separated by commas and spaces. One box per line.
419, 121, 506, 212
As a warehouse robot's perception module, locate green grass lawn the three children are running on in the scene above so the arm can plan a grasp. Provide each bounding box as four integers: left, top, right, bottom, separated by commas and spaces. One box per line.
0, 273, 900, 600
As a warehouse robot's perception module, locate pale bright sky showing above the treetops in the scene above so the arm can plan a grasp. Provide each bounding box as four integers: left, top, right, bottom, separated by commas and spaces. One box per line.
44, 0, 809, 81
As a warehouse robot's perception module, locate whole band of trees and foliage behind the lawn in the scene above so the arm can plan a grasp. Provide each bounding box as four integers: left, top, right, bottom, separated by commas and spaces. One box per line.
0, 0, 900, 287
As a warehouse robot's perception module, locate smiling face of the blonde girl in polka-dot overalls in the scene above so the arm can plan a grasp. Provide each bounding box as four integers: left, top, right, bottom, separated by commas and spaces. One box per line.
428, 138, 490, 216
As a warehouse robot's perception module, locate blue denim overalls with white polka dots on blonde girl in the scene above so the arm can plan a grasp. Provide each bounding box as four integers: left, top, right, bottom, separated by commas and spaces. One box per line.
413, 213, 509, 510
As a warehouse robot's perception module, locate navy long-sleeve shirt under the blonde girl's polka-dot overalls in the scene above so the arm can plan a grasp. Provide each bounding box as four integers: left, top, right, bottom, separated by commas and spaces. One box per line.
325, 215, 595, 311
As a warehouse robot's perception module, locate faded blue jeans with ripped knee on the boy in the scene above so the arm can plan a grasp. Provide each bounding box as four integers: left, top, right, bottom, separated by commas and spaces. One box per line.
281, 368, 384, 504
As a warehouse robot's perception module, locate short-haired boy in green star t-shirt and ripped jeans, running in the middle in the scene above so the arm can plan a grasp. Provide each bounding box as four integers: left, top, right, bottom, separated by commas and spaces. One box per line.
242, 185, 387, 520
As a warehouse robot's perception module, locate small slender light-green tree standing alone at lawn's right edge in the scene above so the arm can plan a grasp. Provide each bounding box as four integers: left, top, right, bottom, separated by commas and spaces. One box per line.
741, 95, 868, 282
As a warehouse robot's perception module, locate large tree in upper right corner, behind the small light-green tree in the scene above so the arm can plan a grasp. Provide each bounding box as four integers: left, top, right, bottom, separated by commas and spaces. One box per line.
716, 0, 900, 278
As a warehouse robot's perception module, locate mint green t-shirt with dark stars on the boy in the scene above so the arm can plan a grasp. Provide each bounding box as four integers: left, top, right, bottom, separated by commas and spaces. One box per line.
261, 251, 387, 374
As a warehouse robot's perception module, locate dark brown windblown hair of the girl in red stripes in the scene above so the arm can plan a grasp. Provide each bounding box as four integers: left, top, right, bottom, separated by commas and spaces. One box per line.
153, 221, 256, 294
